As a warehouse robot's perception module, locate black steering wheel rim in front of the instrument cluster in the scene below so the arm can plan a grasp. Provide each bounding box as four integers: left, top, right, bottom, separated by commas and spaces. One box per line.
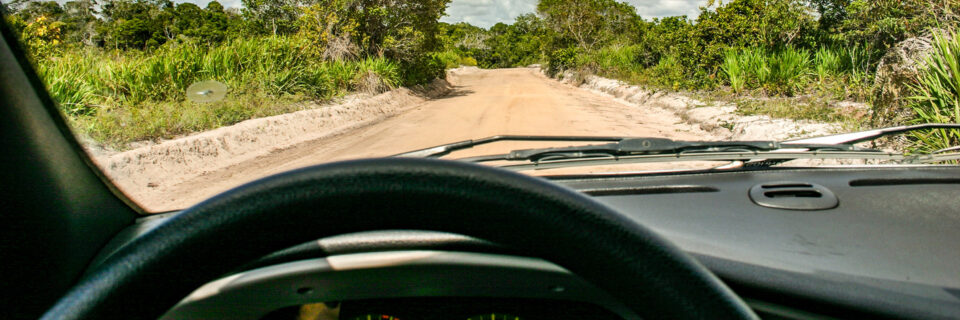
43, 158, 756, 319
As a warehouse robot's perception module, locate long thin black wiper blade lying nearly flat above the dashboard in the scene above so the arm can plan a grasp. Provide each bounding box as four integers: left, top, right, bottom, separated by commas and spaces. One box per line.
460, 138, 869, 162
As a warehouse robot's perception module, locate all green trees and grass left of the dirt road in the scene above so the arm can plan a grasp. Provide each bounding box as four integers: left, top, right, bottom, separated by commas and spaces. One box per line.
4, 0, 456, 148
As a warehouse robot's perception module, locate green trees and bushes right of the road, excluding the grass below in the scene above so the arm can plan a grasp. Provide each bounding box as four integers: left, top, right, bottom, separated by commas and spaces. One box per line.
438, 0, 960, 94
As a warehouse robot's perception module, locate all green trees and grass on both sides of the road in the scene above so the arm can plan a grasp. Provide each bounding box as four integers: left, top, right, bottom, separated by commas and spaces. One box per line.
5, 0, 960, 150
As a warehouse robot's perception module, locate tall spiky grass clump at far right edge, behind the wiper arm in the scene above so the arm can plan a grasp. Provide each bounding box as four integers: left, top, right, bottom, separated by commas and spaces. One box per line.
911, 31, 960, 152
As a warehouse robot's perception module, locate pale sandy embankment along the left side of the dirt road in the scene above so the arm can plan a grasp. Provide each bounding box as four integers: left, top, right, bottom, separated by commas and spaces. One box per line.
91, 80, 451, 208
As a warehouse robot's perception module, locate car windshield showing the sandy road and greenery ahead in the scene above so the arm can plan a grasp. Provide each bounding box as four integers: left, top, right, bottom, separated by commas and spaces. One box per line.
3, 0, 960, 212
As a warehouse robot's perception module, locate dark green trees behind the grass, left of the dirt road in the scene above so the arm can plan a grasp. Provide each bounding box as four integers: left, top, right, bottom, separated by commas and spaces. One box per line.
4, 0, 450, 84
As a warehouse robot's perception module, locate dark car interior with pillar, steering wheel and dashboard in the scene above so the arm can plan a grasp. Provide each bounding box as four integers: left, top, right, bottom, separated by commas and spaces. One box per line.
0, 13, 960, 319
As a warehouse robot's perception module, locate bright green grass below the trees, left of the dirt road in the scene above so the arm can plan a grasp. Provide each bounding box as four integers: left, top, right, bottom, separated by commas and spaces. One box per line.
36, 36, 403, 149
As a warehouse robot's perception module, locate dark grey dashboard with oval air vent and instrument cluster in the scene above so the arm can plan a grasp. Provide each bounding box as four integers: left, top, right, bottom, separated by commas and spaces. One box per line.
94, 167, 960, 319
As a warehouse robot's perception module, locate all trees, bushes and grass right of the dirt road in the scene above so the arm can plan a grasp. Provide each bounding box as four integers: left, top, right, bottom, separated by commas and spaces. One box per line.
442, 0, 960, 149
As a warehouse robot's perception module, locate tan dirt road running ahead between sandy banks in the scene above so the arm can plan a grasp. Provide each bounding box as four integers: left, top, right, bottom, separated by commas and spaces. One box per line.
131, 68, 706, 211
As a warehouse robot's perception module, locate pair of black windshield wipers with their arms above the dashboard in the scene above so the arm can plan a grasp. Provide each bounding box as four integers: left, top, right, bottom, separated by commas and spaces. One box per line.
395, 124, 960, 166
